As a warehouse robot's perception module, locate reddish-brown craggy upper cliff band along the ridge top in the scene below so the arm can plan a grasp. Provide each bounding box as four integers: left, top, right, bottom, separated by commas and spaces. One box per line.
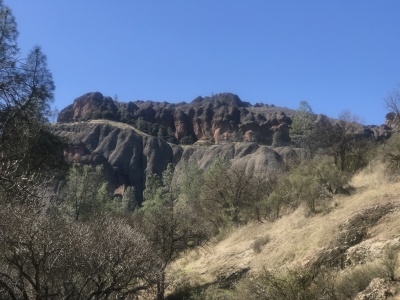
58, 92, 292, 146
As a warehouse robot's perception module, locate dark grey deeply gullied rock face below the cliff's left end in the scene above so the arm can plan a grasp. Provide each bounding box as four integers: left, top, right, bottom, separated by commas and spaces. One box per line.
53, 122, 182, 200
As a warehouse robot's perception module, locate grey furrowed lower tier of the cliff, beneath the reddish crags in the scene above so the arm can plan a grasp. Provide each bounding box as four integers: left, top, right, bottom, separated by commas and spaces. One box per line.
53, 120, 297, 200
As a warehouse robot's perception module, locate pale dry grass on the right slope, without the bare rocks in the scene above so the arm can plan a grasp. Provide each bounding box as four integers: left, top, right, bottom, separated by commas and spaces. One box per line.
175, 165, 400, 283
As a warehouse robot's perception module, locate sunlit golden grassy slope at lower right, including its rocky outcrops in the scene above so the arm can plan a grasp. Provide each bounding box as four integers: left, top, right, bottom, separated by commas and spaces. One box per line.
171, 166, 400, 299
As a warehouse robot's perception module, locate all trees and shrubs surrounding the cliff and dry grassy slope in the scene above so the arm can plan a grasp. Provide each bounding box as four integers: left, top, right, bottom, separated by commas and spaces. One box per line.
0, 0, 400, 300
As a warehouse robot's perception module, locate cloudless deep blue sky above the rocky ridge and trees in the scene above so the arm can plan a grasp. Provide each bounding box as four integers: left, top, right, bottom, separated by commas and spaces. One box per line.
9, 0, 400, 125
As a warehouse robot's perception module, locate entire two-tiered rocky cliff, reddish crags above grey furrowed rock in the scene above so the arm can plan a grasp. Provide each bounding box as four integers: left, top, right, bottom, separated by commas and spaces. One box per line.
53, 92, 391, 200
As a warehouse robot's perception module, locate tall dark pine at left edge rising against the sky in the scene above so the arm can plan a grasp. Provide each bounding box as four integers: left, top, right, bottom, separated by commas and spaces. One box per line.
0, 1, 63, 201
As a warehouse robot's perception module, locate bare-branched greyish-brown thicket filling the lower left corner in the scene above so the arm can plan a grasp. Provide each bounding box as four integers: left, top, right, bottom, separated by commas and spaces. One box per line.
0, 205, 159, 300
